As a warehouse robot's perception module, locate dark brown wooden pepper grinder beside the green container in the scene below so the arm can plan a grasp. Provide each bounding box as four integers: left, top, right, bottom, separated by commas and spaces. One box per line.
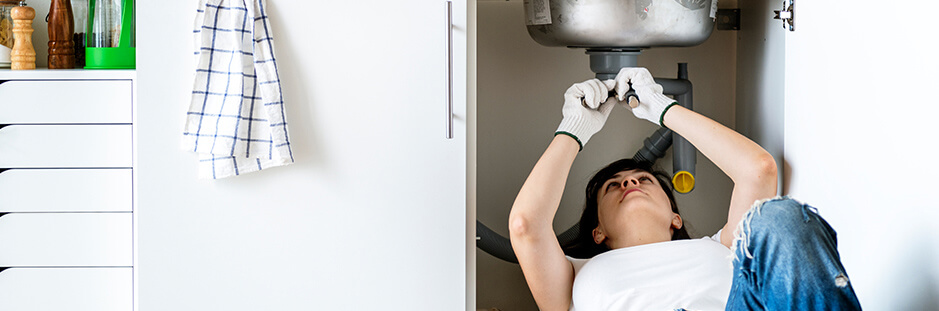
48, 0, 75, 69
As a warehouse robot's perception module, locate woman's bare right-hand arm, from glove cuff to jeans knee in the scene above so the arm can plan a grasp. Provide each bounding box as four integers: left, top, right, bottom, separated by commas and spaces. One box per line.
662, 105, 777, 247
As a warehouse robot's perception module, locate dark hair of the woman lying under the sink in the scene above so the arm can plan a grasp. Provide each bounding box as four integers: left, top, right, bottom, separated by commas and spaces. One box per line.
563, 158, 691, 258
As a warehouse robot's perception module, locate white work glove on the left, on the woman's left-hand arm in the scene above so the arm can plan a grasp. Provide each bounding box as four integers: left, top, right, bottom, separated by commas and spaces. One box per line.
554, 79, 616, 150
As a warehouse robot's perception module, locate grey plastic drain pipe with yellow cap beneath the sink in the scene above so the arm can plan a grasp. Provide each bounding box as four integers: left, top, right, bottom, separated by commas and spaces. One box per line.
586, 48, 697, 194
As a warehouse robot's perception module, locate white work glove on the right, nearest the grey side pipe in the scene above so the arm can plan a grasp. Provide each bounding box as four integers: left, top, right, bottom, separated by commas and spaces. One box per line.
616, 67, 678, 126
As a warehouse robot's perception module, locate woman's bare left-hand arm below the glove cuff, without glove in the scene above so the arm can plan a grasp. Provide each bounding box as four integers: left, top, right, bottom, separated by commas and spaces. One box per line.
509, 135, 580, 311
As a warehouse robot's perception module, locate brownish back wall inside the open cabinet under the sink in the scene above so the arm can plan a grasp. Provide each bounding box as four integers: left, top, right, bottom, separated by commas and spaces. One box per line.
476, 0, 736, 311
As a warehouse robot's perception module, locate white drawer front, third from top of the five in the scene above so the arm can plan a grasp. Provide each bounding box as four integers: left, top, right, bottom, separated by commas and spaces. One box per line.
0, 169, 133, 213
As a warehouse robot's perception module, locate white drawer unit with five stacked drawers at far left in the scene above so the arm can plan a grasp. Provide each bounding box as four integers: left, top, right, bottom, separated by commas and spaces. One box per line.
0, 69, 136, 311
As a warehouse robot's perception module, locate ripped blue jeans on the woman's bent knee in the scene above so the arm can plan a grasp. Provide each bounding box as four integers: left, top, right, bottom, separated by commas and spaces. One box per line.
726, 197, 861, 310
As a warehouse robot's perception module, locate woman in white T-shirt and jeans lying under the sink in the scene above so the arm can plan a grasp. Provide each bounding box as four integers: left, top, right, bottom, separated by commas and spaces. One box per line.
509, 68, 860, 311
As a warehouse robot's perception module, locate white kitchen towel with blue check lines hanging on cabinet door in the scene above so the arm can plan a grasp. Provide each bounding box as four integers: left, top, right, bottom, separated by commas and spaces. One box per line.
183, 0, 293, 179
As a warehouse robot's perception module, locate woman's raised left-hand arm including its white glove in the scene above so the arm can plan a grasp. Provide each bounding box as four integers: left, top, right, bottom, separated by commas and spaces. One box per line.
509, 79, 616, 311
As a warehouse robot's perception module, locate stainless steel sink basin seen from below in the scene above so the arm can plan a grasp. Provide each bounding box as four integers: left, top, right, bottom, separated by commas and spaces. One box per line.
525, 0, 717, 48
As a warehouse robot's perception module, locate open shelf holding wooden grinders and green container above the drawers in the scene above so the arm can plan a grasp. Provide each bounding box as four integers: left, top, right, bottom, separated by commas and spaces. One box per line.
0, 0, 136, 70
